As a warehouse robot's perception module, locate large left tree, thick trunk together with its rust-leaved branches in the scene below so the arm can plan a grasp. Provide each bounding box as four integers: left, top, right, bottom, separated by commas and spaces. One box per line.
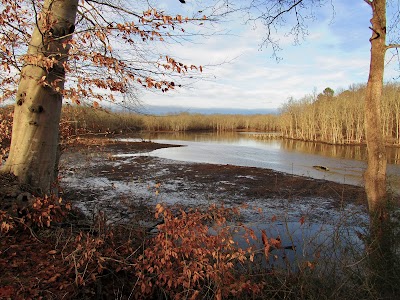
0, 0, 208, 194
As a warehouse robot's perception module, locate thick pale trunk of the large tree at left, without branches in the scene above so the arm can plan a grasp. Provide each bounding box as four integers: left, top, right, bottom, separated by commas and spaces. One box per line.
2, 0, 78, 193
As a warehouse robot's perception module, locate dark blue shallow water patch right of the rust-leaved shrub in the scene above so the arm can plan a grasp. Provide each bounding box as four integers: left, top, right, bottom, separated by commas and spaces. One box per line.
234, 221, 367, 271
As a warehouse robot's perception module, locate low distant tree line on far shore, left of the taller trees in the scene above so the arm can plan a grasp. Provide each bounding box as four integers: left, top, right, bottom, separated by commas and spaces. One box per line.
61, 106, 279, 132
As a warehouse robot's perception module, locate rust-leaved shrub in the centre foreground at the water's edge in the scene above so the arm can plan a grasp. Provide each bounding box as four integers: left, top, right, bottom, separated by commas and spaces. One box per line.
136, 205, 261, 299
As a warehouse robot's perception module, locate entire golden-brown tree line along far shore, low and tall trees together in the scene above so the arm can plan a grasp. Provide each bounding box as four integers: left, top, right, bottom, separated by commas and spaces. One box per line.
2, 83, 400, 145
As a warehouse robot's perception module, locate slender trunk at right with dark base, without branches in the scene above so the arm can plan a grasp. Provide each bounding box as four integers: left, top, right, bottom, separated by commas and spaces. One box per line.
365, 0, 399, 299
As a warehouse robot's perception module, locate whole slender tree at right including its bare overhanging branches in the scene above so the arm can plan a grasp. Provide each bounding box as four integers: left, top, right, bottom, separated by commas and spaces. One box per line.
238, 0, 400, 292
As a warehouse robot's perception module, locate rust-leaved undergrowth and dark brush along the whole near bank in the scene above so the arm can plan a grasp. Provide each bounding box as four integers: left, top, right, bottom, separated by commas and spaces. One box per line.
0, 193, 399, 299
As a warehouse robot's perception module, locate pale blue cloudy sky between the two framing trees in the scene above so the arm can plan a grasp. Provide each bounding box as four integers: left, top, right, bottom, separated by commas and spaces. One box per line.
137, 0, 397, 111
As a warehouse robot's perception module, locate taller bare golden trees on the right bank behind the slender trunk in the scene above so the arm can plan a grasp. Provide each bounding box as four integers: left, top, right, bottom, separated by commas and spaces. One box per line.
279, 83, 400, 145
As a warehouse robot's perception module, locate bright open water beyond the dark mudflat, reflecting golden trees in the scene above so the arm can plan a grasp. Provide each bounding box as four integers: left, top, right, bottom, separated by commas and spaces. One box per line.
118, 133, 400, 191
